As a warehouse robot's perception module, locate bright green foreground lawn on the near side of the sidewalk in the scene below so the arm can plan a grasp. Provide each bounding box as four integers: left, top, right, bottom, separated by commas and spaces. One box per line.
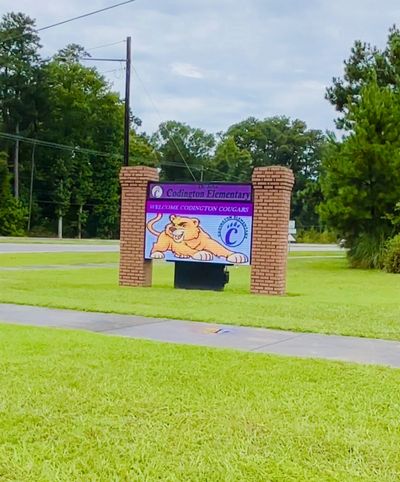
0, 325, 400, 482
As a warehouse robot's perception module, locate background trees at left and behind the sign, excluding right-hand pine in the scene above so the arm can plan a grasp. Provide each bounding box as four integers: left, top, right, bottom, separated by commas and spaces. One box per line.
0, 13, 324, 237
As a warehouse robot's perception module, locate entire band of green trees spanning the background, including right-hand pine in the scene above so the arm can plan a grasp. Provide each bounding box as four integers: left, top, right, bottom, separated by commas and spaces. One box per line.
0, 13, 400, 266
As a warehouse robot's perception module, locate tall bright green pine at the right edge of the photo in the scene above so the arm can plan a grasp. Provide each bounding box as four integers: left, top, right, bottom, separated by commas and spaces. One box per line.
318, 26, 400, 272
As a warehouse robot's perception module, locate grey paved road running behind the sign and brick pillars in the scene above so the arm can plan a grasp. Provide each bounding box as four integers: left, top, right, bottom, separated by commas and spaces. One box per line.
0, 242, 343, 254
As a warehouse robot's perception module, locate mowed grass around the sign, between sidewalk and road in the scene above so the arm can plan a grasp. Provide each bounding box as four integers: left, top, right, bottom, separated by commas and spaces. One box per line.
0, 253, 400, 339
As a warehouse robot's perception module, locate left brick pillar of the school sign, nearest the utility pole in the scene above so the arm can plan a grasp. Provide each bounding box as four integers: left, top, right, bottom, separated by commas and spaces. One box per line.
119, 166, 159, 286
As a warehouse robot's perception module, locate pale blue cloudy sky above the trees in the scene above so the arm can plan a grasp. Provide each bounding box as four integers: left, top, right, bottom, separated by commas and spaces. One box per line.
0, 0, 400, 133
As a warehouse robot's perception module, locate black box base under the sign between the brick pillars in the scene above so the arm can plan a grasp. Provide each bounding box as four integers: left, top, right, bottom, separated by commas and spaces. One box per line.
174, 261, 229, 291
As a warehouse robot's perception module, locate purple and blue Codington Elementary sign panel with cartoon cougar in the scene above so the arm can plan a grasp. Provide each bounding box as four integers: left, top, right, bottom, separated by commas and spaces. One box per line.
145, 183, 253, 265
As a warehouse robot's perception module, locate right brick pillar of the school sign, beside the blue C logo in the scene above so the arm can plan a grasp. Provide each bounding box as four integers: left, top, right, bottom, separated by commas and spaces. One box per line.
250, 166, 294, 295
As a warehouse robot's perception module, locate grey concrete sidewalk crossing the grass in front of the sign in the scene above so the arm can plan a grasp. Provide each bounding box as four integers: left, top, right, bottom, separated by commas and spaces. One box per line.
0, 304, 400, 368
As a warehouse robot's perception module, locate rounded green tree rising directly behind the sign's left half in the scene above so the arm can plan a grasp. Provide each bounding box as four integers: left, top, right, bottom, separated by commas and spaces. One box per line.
151, 121, 215, 181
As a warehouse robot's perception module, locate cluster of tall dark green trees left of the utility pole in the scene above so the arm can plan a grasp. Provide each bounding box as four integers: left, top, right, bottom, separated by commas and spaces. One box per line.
0, 13, 126, 237
